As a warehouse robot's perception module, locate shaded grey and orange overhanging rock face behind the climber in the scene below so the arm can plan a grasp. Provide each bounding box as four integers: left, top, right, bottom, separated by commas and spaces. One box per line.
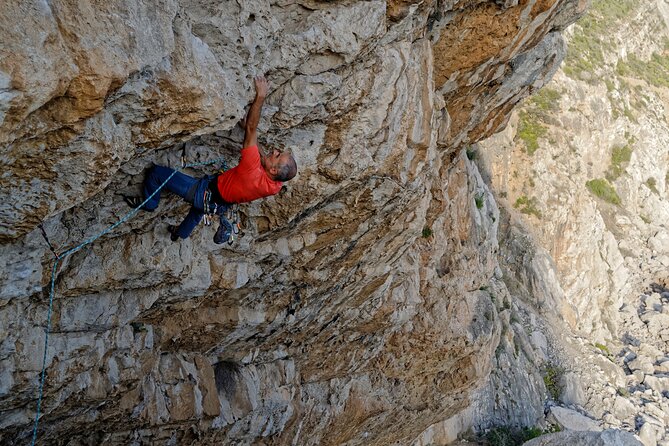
0, 1, 584, 445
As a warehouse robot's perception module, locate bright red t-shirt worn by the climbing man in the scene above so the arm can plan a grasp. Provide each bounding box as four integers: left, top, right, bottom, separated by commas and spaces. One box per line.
217, 146, 283, 203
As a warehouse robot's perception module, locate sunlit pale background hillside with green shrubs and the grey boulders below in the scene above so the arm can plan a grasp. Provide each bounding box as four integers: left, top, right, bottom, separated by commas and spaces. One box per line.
477, 0, 669, 445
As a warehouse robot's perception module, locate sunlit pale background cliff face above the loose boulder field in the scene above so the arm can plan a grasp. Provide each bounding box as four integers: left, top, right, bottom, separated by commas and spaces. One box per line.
482, 0, 669, 340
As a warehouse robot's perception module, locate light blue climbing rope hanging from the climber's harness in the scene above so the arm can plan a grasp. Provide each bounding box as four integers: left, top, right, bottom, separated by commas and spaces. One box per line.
31, 158, 227, 446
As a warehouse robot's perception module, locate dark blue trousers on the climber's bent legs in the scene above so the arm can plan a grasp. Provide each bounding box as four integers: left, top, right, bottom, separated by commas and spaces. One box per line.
144, 166, 213, 238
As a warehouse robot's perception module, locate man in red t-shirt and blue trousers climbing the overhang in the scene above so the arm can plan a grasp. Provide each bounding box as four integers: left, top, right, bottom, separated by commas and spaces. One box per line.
123, 76, 297, 244
